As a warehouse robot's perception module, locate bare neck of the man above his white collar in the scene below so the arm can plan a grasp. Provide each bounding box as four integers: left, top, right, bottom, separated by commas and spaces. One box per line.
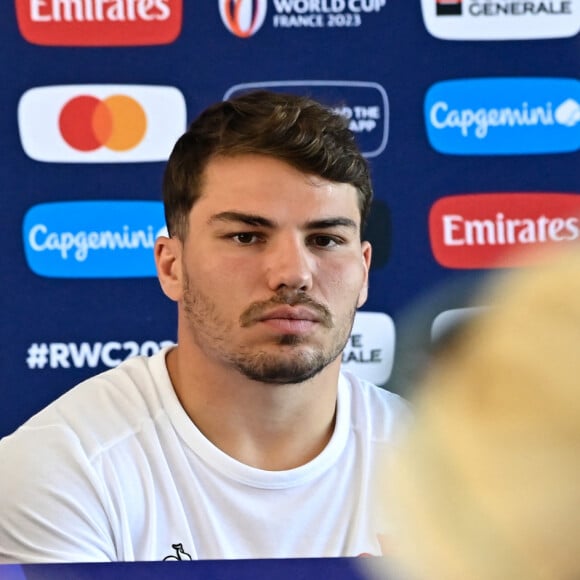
167, 347, 340, 471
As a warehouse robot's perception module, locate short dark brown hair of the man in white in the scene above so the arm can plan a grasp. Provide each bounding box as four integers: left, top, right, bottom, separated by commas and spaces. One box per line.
163, 90, 372, 239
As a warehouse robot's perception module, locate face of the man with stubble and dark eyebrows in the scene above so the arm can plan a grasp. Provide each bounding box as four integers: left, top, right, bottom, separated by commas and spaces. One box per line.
178, 155, 371, 383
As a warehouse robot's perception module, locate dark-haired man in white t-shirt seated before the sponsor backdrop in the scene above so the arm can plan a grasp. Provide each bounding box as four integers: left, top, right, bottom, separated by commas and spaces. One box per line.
0, 91, 404, 562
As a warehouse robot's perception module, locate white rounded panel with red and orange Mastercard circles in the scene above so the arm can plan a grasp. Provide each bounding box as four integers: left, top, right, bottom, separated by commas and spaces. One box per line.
18, 85, 186, 163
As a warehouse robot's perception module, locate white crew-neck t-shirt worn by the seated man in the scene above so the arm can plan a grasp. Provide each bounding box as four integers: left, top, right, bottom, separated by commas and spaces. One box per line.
0, 350, 405, 562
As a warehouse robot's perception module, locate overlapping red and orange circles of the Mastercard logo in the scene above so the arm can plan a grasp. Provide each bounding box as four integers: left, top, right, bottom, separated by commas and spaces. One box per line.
58, 95, 147, 151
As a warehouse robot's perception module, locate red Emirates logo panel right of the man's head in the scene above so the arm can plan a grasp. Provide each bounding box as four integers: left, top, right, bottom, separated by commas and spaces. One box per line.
429, 192, 580, 269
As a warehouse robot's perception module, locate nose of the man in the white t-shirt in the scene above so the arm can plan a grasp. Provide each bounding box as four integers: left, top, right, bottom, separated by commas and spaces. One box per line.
266, 236, 315, 291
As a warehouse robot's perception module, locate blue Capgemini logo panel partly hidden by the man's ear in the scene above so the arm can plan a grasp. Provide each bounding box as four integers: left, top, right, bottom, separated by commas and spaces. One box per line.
22, 201, 166, 278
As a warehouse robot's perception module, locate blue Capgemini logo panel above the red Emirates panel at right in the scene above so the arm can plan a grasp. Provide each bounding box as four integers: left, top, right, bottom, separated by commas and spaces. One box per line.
425, 77, 580, 155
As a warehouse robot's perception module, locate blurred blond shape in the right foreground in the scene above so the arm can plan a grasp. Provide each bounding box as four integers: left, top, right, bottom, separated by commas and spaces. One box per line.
382, 246, 580, 580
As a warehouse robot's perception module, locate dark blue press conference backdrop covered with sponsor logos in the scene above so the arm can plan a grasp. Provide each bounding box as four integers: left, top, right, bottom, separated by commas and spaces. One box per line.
0, 0, 580, 436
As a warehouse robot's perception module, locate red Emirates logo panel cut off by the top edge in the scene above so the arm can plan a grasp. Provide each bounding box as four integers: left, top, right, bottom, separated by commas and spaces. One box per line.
16, 0, 182, 46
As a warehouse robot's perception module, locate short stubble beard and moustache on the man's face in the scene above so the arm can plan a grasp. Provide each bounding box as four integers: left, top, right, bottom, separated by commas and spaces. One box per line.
183, 276, 356, 384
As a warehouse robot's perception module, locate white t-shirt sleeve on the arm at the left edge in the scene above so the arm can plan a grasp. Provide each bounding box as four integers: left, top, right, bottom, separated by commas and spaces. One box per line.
0, 426, 117, 563
